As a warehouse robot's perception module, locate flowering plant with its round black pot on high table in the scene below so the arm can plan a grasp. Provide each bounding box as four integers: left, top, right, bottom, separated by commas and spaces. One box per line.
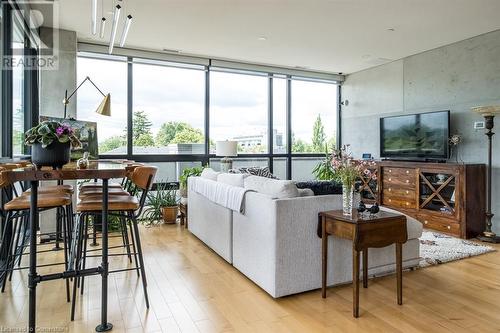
24, 121, 81, 169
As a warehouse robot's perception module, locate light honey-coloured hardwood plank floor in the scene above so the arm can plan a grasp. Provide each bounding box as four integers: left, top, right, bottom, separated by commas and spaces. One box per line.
0, 225, 500, 332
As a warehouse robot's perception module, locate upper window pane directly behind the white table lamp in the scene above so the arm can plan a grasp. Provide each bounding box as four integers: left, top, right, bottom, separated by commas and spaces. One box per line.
210, 72, 269, 154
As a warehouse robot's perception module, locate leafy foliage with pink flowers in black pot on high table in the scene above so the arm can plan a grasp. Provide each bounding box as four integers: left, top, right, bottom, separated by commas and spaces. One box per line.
24, 121, 81, 148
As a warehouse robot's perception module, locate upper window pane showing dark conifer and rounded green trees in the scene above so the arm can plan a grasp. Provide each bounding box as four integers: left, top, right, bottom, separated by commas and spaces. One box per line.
132, 63, 205, 155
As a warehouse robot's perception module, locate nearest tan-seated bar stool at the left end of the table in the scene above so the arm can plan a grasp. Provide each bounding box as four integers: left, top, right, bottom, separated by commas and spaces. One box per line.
0, 169, 73, 296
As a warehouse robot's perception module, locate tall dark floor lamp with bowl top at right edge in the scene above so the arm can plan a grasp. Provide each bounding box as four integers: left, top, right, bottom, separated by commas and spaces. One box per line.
472, 105, 500, 243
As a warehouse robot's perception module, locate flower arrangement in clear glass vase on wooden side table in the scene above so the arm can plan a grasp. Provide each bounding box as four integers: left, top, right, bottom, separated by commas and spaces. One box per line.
331, 145, 374, 216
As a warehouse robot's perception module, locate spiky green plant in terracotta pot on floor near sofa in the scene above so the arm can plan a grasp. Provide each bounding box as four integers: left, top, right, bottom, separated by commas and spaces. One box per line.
142, 183, 178, 225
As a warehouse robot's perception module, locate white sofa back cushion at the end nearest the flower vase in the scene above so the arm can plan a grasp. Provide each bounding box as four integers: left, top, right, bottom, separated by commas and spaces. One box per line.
244, 176, 299, 199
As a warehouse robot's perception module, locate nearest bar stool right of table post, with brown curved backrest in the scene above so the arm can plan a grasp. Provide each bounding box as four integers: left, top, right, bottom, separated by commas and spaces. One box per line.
71, 166, 158, 320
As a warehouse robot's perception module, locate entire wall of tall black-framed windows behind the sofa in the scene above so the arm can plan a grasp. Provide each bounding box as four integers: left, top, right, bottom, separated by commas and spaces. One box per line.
77, 53, 338, 181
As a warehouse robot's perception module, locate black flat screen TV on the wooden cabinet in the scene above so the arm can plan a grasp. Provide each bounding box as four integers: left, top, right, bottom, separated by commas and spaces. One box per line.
380, 110, 450, 160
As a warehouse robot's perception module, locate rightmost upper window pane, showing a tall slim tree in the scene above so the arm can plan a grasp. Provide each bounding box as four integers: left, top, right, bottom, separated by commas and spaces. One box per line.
291, 80, 337, 153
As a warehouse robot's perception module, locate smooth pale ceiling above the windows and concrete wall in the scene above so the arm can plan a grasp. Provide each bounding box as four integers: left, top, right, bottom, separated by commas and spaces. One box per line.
42, 0, 500, 73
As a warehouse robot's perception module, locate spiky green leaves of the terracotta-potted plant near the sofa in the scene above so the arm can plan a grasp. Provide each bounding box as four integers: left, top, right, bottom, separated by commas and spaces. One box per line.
141, 182, 178, 226
